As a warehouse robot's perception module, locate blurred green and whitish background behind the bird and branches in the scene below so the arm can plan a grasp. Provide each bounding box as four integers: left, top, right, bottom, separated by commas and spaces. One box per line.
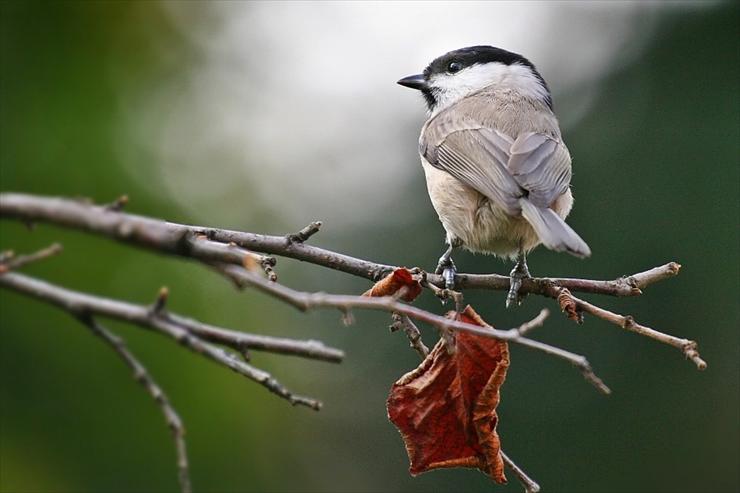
0, 1, 740, 493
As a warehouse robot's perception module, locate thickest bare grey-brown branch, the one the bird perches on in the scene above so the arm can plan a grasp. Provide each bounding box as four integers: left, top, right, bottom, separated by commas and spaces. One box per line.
0, 193, 677, 296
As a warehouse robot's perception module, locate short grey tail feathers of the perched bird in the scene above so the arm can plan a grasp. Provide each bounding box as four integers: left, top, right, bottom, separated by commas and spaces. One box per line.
519, 199, 591, 258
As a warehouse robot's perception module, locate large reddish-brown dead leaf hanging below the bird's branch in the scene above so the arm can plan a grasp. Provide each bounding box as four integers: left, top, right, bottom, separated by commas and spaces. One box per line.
387, 306, 509, 483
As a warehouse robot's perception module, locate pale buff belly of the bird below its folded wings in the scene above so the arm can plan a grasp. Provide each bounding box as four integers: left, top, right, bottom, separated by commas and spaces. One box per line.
422, 159, 573, 258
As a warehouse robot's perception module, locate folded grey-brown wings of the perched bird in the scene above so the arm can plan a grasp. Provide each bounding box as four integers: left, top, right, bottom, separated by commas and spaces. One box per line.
420, 115, 571, 215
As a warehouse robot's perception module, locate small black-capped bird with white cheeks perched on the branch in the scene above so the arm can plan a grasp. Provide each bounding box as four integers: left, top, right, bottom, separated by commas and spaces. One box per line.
398, 46, 591, 307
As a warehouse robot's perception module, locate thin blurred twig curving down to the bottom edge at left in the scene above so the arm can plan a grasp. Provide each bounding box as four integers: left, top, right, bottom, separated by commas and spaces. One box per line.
78, 315, 192, 493
